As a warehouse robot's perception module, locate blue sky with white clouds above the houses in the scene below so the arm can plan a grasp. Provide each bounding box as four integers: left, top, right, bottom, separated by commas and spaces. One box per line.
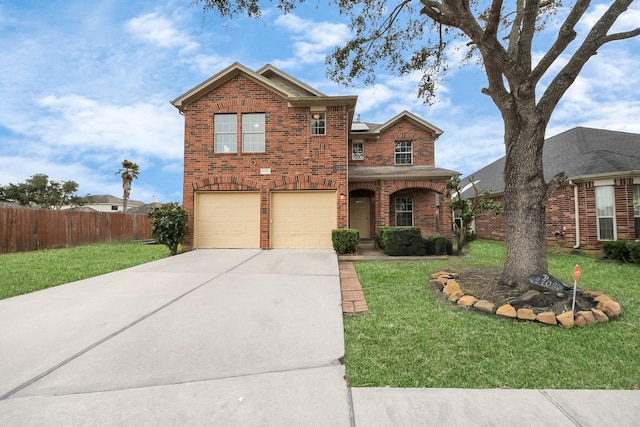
0, 0, 640, 203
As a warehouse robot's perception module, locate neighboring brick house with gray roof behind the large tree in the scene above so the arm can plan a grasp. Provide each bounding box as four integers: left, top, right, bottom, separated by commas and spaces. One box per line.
462, 127, 640, 251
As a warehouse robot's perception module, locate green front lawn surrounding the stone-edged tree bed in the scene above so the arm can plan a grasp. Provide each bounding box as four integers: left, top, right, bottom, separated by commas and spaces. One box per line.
344, 241, 640, 389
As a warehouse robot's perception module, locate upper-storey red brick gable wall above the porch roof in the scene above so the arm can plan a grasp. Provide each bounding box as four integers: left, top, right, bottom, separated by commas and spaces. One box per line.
349, 119, 435, 166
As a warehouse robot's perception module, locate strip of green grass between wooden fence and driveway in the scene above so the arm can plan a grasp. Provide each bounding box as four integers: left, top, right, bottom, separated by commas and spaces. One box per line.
0, 243, 169, 300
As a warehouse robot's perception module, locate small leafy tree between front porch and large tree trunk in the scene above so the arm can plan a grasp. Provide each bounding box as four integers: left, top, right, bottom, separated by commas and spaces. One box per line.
447, 176, 502, 255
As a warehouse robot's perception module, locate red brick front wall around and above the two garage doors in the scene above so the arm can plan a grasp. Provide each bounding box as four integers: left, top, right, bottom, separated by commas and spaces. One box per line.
183, 75, 348, 249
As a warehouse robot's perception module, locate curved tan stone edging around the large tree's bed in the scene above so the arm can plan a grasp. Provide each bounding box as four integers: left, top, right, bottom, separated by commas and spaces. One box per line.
431, 271, 622, 329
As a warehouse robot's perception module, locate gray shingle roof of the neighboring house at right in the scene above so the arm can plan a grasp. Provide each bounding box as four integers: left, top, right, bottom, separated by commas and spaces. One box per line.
461, 127, 640, 197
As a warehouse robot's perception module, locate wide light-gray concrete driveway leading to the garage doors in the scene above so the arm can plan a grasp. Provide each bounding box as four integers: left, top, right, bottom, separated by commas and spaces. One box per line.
0, 249, 351, 426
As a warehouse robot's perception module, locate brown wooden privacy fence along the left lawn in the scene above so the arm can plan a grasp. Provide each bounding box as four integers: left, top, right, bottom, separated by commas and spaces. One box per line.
0, 207, 152, 253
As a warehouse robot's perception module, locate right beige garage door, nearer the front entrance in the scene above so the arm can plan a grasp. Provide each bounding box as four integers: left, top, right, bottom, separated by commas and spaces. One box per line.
271, 191, 337, 249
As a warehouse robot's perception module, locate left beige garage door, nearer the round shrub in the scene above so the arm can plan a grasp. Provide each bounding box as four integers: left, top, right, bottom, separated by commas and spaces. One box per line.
194, 191, 260, 248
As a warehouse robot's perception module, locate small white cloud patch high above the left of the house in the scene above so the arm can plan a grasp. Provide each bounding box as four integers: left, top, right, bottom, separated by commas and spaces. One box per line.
125, 12, 198, 50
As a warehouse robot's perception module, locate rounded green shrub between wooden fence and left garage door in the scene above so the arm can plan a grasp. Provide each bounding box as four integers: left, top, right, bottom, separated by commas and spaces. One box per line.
149, 202, 189, 255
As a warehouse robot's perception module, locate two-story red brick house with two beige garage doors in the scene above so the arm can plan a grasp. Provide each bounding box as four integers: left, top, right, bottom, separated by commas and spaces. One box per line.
171, 63, 455, 249
